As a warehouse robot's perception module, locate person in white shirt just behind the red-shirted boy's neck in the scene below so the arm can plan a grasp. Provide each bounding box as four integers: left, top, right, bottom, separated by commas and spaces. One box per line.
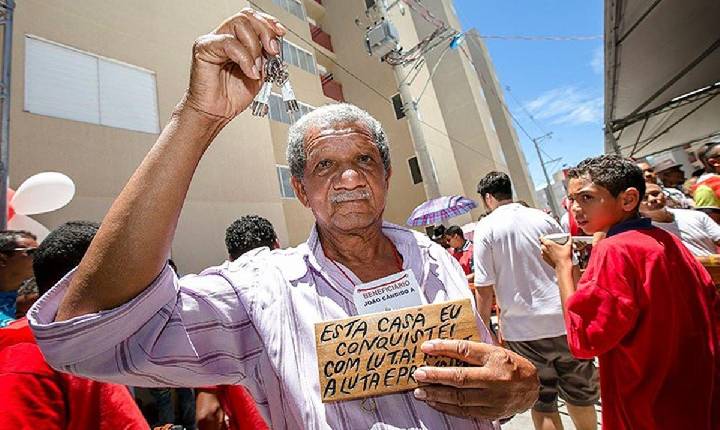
640, 183, 720, 257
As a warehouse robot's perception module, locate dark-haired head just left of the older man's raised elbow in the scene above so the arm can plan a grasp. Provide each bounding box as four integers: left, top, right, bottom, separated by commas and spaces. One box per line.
33, 221, 100, 295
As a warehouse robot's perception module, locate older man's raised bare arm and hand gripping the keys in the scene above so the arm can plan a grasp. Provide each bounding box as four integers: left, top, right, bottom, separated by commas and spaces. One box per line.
56, 9, 285, 321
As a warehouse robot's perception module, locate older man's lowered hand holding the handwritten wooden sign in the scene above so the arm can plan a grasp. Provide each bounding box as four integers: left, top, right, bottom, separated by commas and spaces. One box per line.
414, 339, 540, 419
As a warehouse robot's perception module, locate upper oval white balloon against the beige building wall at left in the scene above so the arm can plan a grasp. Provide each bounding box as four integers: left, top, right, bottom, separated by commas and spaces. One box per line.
10, 172, 75, 215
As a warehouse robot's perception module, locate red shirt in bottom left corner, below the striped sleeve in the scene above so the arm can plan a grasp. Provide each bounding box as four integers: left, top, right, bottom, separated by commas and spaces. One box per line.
0, 318, 150, 430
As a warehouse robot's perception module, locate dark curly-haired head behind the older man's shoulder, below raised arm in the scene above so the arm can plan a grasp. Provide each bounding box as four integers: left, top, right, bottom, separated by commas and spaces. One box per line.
225, 215, 277, 260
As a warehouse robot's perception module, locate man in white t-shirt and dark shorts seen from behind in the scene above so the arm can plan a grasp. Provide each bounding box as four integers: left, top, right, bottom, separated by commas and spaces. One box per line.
473, 172, 599, 430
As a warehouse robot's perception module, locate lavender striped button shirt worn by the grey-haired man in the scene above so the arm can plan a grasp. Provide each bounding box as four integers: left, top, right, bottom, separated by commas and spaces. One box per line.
28, 223, 494, 430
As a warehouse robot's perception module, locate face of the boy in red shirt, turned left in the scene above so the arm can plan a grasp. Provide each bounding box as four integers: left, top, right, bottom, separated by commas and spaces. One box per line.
568, 177, 640, 234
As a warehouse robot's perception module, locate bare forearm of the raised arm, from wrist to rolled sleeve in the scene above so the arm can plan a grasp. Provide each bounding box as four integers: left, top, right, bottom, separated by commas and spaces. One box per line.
56, 106, 224, 321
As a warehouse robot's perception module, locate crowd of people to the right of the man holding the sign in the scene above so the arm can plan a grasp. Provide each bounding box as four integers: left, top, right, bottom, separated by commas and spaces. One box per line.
433, 155, 720, 429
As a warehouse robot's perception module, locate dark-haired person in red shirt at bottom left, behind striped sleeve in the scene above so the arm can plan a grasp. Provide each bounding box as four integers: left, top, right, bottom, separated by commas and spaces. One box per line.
0, 221, 150, 430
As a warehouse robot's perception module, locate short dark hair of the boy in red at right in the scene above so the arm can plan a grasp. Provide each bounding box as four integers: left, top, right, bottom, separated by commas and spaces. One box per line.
567, 154, 645, 200
